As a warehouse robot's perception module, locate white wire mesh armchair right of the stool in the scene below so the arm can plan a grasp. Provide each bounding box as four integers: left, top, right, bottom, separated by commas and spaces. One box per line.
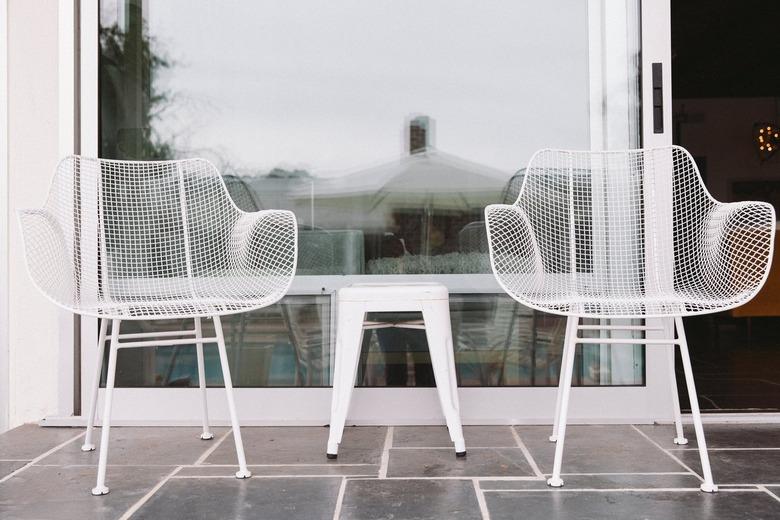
485, 146, 775, 492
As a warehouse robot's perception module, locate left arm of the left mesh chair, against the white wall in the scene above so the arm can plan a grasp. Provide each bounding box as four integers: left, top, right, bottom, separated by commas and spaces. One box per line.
18, 209, 76, 310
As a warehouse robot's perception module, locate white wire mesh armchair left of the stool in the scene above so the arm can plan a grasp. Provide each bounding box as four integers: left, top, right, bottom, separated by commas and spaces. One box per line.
19, 156, 297, 495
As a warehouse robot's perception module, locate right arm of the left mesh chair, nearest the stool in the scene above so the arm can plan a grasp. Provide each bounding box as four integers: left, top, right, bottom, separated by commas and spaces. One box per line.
230, 210, 298, 284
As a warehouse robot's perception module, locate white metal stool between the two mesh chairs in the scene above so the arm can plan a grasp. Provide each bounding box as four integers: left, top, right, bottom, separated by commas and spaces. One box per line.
328, 283, 466, 459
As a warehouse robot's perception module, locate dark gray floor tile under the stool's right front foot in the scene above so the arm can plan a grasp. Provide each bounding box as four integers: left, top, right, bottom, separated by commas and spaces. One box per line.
387, 448, 534, 477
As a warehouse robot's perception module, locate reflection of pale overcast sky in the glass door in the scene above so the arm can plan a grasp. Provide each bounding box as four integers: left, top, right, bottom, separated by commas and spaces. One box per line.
104, 0, 588, 175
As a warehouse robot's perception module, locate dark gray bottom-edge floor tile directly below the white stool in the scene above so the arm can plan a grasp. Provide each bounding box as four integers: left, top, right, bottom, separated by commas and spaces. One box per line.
341, 480, 482, 520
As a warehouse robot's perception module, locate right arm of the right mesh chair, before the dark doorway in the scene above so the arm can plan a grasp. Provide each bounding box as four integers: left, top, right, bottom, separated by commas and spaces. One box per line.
700, 201, 776, 303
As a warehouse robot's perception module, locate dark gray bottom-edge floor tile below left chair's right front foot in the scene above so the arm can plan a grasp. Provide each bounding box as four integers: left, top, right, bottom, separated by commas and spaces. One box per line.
133, 478, 342, 520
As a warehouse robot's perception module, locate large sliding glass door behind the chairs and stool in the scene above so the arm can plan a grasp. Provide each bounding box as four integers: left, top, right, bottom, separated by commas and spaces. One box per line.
74, 0, 676, 423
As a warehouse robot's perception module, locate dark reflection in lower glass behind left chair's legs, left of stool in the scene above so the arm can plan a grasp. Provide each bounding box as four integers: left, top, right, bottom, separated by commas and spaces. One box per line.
103, 296, 330, 387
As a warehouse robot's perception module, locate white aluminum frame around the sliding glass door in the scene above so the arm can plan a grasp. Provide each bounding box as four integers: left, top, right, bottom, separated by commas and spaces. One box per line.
43, 0, 688, 425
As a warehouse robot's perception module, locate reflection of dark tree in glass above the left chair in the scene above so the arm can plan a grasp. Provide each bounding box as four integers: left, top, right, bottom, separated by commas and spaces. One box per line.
99, 0, 174, 159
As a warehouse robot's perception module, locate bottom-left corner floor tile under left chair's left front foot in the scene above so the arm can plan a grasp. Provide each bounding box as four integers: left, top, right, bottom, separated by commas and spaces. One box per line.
0, 466, 170, 520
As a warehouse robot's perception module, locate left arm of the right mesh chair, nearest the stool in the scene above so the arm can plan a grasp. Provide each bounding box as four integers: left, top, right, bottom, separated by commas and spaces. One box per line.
485, 204, 545, 303
